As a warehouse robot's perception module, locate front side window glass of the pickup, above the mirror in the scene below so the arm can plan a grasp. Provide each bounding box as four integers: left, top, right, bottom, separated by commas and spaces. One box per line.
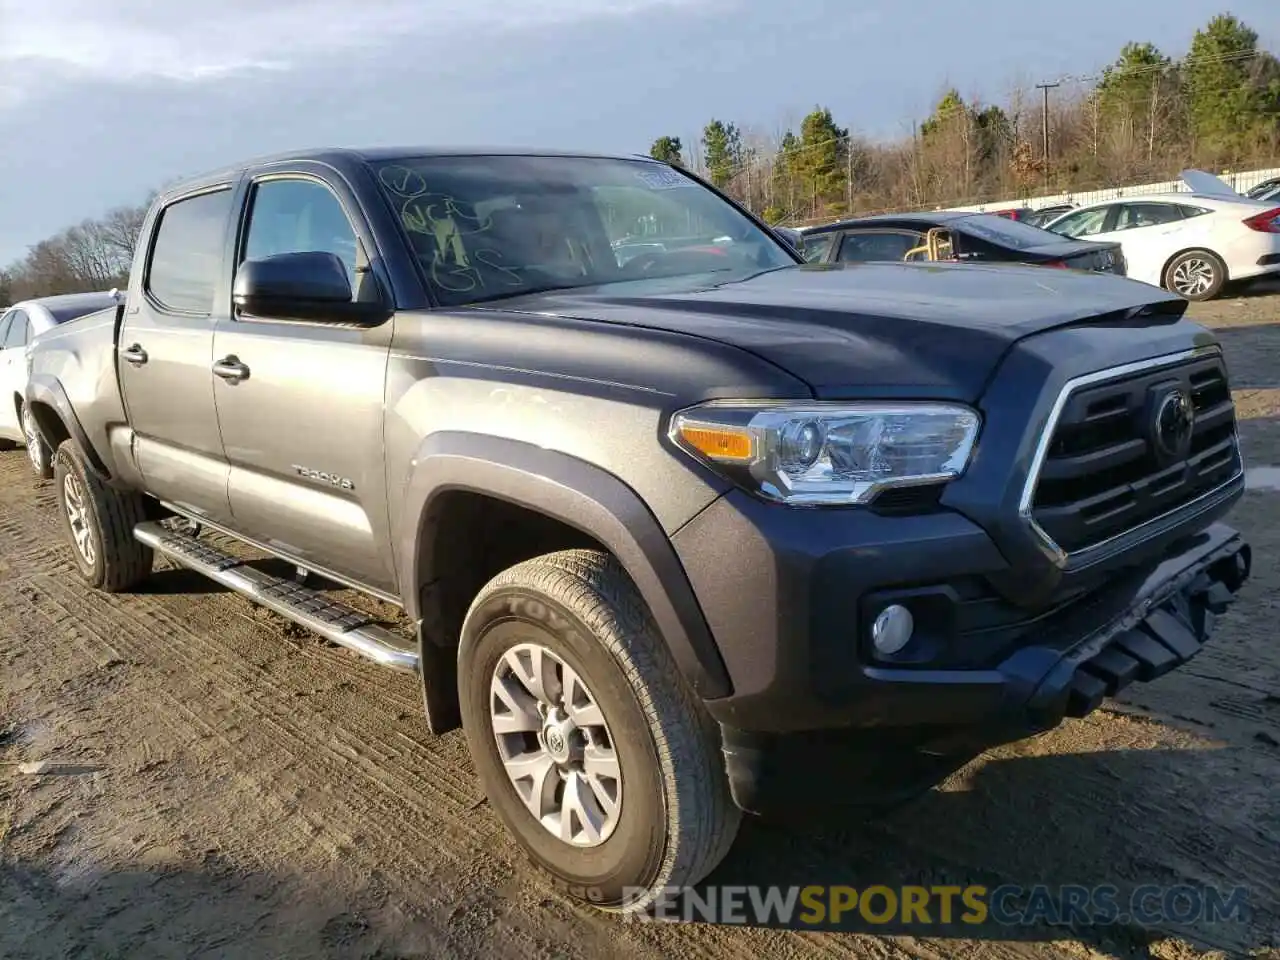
242, 179, 364, 291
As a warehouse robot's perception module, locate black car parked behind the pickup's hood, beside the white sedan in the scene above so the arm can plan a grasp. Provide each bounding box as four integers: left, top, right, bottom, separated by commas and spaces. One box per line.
801, 210, 1125, 275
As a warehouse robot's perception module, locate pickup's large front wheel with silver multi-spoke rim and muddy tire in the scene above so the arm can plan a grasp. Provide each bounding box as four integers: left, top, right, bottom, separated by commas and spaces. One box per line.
458, 550, 741, 913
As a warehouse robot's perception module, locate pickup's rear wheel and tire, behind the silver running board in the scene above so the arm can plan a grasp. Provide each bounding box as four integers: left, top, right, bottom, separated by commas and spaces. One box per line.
54, 440, 155, 593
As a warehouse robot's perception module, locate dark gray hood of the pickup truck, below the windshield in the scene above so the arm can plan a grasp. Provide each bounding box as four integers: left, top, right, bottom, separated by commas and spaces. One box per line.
480, 264, 1187, 402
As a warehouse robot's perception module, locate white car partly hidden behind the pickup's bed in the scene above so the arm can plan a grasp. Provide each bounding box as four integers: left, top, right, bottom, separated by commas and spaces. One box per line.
0, 291, 116, 480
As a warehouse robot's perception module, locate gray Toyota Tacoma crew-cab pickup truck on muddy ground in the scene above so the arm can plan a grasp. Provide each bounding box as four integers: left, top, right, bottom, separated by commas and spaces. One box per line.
27, 148, 1251, 910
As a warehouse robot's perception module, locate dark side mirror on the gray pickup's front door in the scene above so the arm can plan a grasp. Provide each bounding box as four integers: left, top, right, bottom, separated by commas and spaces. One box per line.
232, 251, 390, 325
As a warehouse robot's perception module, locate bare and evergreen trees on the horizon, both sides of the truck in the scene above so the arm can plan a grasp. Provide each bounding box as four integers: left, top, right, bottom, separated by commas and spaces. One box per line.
0, 14, 1280, 303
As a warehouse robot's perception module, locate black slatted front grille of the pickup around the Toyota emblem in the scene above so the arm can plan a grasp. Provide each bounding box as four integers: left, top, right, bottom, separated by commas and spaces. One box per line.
1030, 353, 1240, 554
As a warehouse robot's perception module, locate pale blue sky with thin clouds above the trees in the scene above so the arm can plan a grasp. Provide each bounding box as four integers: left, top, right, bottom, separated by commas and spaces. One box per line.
0, 0, 1280, 264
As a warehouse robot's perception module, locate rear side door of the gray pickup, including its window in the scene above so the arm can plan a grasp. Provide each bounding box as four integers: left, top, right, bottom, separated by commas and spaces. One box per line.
116, 183, 234, 522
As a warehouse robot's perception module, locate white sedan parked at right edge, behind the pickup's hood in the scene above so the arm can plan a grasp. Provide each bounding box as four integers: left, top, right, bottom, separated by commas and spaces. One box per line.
1044, 170, 1280, 300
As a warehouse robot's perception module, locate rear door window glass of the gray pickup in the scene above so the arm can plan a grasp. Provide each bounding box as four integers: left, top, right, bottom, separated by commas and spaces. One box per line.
147, 189, 232, 315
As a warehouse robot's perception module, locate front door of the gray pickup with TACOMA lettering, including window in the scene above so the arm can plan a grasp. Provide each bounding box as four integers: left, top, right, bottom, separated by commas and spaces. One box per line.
214, 173, 396, 595
